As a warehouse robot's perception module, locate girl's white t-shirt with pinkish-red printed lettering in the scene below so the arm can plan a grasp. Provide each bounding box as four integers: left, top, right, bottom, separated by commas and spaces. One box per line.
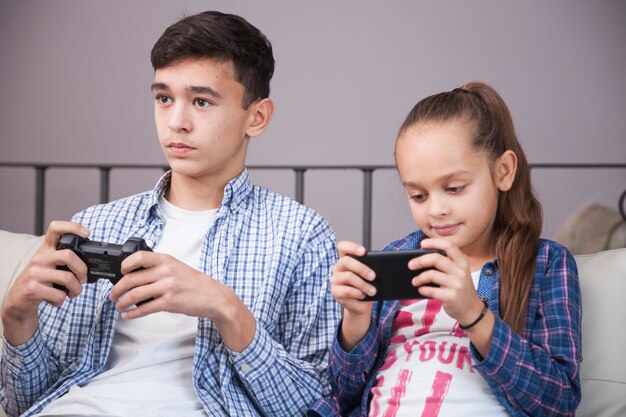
369, 272, 509, 417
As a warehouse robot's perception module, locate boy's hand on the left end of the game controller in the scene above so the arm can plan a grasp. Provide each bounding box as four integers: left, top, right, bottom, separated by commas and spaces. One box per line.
2, 221, 89, 346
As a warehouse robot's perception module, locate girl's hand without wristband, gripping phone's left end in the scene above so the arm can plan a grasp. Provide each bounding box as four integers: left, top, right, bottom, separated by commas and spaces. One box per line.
330, 241, 376, 352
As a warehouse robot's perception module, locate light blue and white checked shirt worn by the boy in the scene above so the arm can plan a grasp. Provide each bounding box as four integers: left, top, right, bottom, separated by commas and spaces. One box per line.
0, 171, 341, 416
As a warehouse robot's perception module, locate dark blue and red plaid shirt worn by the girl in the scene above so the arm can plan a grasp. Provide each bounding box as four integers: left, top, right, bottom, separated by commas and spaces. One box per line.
308, 230, 582, 417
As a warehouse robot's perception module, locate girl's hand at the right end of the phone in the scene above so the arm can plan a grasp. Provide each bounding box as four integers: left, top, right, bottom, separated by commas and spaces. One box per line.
409, 239, 484, 324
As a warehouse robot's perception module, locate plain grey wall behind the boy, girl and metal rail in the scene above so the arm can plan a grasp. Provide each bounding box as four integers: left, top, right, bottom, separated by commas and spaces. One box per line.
0, 0, 626, 247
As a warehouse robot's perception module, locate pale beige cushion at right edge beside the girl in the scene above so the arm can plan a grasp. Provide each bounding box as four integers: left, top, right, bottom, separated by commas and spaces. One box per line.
576, 249, 626, 417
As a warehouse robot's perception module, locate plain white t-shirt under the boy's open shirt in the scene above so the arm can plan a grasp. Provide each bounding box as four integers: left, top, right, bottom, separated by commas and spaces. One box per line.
38, 197, 217, 417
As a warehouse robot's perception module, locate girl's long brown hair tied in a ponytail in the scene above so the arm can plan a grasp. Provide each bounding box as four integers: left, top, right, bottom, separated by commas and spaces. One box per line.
398, 81, 543, 334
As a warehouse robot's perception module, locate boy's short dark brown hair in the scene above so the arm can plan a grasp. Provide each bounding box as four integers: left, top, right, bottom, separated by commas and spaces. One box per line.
151, 11, 274, 108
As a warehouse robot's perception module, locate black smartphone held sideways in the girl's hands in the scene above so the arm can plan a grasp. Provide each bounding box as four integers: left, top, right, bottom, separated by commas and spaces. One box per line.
350, 249, 446, 301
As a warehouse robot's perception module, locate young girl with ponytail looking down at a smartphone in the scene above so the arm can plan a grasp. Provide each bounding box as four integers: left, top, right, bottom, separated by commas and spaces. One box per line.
309, 82, 581, 417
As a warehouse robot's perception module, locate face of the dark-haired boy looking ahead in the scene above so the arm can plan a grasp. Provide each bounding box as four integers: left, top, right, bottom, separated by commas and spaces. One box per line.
152, 59, 255, 184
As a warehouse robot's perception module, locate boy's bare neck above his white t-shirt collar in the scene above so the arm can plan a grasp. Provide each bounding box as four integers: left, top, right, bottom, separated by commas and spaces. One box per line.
165, 172, 240, 211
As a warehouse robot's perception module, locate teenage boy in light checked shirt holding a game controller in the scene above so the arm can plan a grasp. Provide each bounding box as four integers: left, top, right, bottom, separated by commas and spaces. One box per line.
0, 12, 340, 416
